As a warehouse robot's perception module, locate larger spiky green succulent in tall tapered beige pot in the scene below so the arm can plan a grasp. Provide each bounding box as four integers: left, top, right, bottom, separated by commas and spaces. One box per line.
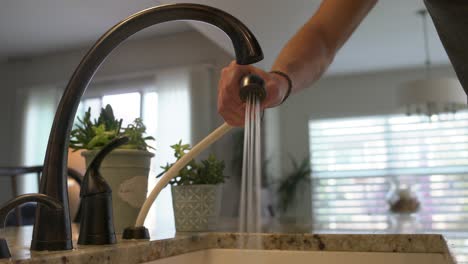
70, 105, 154, 233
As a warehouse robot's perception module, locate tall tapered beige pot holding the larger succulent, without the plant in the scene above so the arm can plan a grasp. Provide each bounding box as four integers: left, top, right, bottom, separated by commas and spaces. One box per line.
81, 149, 154, 233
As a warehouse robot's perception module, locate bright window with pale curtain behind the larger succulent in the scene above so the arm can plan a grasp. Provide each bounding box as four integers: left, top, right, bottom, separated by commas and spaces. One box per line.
77, 68, 193, 234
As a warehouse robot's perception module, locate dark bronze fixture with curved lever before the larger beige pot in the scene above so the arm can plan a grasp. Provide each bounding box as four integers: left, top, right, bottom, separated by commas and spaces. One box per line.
78, 137, 129, 245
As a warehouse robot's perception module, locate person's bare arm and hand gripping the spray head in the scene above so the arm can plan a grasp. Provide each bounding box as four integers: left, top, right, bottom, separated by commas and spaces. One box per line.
218, 0, 377, 126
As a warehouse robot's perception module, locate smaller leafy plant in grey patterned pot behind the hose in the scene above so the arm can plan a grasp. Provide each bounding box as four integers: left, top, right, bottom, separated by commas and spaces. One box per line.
158, 141, 225, 232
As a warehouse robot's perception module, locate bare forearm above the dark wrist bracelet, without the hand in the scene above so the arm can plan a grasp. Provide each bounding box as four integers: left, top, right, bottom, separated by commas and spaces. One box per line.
272, 0, 377, 92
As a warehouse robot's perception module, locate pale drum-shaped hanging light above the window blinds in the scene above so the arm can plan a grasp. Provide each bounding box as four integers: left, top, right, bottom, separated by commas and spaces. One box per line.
397, 10, 467, 118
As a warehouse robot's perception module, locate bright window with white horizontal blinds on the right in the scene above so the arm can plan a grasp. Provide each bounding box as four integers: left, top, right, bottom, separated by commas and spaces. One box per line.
309, 111, 468, 263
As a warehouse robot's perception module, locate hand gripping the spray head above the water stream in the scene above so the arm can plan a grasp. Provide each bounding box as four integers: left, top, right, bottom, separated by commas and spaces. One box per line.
218, 61, 288, 126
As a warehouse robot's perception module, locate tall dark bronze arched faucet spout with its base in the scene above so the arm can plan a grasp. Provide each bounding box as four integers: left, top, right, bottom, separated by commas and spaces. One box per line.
31, 4, 263, 250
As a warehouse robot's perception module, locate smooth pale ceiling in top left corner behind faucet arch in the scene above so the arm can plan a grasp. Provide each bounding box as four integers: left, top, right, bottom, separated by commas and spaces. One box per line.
0, 0, 193, 60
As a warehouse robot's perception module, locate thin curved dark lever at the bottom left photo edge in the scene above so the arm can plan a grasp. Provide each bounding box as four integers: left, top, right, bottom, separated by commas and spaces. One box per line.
0, 193, 63, 259
